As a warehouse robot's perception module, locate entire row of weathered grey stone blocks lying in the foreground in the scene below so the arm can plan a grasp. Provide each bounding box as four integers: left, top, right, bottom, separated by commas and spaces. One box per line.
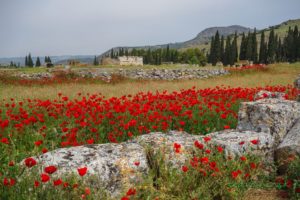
22, 90, 300, 196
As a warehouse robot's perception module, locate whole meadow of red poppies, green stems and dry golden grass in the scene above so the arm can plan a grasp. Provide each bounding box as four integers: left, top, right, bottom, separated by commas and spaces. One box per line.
0, 64, 300, 200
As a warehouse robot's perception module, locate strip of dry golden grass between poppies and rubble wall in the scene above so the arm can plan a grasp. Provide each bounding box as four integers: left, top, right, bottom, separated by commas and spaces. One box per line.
0, 63, 300, 100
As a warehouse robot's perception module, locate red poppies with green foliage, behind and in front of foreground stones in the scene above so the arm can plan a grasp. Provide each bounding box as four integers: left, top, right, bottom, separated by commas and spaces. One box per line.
0, 63, 299, 200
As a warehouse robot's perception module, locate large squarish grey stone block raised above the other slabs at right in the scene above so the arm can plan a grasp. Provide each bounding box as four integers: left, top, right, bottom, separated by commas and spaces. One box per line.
237, 98, 300, 146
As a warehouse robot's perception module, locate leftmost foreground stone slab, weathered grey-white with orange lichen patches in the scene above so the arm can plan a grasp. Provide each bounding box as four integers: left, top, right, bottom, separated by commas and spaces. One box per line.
23, 143, 148, 196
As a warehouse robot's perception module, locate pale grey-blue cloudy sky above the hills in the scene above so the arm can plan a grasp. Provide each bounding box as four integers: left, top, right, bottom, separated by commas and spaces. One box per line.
0, 0, 300, 57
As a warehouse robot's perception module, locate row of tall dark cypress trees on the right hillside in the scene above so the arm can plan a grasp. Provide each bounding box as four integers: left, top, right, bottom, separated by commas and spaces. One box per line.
207, 26, 300, 65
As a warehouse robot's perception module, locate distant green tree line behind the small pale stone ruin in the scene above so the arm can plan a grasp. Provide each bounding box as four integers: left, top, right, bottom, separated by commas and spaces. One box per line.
108, 45, 207, 66
